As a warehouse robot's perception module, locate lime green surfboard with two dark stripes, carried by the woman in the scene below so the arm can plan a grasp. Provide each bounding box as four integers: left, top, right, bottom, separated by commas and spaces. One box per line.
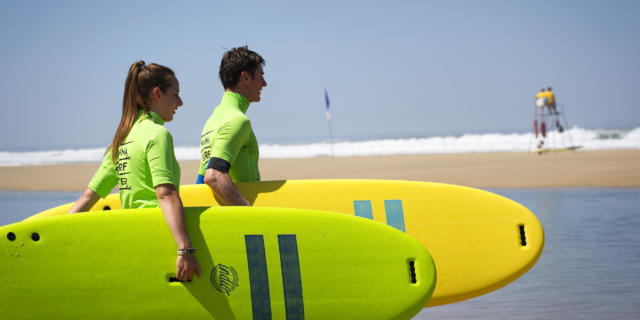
0, 207, 435, 319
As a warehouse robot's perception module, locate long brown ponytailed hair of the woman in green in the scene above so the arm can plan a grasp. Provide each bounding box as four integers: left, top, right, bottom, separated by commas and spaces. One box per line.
107, 60, 175, 163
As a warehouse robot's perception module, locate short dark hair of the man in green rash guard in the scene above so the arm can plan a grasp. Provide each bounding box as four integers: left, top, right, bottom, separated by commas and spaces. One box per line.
219, 46, 265, 90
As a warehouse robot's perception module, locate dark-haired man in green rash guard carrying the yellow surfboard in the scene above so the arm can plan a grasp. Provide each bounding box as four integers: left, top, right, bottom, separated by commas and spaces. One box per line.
198, 46, 267, 206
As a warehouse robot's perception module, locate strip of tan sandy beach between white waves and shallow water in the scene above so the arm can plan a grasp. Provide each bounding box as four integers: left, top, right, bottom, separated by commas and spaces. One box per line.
0, 150, 640, 191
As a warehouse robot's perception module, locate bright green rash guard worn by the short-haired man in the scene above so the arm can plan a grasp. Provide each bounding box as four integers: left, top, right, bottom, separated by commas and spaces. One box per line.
198, 92, 260, 182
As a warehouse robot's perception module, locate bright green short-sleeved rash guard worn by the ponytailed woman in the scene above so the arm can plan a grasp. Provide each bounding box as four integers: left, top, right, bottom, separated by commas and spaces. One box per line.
89, 110, 180, 209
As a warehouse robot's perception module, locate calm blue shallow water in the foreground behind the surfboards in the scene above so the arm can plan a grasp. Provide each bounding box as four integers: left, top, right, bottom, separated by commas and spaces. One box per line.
0, 188, 640, 319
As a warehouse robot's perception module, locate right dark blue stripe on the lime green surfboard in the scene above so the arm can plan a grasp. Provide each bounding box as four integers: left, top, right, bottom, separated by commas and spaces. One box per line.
278, 234, 304, 320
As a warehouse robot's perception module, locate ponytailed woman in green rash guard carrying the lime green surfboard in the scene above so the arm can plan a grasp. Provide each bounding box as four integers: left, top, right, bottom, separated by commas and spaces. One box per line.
69, 61, 200, 281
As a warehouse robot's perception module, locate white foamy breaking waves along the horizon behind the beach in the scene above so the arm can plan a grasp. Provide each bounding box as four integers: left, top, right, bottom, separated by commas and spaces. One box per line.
0, 127, 640, 166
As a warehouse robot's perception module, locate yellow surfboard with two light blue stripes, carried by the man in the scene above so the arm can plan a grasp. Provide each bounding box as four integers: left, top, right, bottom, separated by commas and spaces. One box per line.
27, 180, 544, 306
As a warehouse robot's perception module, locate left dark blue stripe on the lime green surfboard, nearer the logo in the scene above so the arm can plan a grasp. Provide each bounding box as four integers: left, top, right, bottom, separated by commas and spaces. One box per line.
244, 235, 271, 320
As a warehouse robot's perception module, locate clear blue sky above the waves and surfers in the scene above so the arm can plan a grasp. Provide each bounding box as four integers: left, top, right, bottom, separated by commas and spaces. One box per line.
0, 1, 640, 150
